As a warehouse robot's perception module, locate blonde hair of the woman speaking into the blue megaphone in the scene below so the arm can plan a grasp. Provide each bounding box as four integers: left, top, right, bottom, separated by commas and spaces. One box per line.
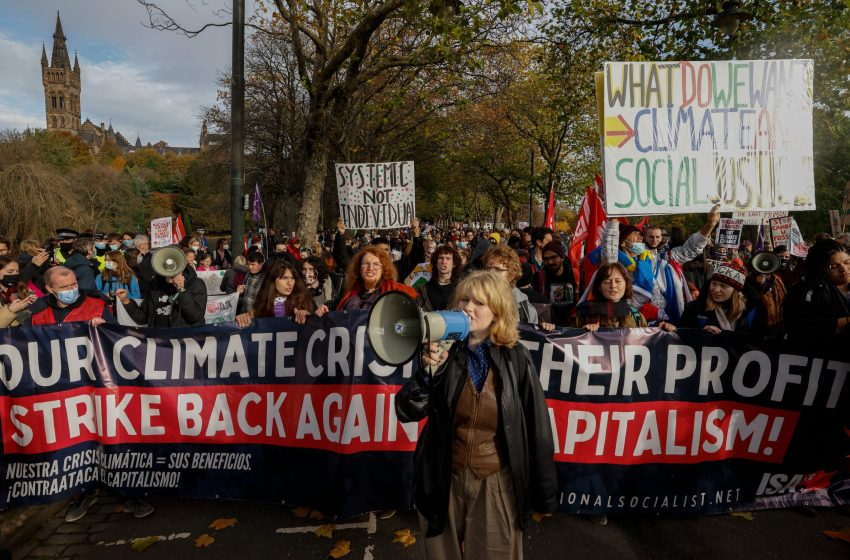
449, 270, 519, 348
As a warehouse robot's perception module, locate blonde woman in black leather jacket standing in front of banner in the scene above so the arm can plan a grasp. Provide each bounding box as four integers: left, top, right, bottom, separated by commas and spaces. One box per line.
395, 271, 557, 559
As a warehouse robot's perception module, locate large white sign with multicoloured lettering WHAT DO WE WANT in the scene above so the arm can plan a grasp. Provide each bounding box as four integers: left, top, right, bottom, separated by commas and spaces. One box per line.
603, 60, 815, 216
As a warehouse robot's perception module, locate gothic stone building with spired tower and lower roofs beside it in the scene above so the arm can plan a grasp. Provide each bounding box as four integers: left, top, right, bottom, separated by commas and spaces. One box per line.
41, 12, 200, 155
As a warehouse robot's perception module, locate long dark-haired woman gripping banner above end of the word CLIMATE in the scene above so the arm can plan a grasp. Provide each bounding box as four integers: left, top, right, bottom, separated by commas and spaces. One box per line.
236, 259, 316, 328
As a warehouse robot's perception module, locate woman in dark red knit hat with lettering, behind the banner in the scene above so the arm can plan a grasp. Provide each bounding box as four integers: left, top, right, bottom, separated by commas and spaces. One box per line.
679, 263, 767, 336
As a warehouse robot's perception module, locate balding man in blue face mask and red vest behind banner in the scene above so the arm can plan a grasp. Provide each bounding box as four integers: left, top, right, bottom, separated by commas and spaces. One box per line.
30, 266, 116, 327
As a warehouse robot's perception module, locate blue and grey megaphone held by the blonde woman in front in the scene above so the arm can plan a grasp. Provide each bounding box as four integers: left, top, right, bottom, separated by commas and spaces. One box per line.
366, 292, 469, 366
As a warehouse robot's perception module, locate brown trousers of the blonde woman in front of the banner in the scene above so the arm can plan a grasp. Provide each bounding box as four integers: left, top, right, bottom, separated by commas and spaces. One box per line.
419, 468, 522, 560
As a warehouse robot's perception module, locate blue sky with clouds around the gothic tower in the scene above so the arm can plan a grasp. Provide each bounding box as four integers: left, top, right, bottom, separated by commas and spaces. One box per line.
0, 0, 254, 146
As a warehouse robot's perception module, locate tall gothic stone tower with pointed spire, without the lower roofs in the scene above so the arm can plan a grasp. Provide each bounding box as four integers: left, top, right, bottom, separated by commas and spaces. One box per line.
41, 12, 80, 134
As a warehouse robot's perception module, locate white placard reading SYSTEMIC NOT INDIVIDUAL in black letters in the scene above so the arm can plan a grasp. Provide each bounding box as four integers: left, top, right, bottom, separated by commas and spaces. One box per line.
336, 161, 416, 229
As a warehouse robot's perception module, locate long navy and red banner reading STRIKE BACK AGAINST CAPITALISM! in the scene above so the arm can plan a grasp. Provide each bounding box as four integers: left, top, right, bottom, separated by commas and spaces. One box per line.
0, 320, 850, 515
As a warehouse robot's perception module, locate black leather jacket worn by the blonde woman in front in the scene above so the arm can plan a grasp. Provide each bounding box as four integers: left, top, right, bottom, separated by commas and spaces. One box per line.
395, 343, 558, 537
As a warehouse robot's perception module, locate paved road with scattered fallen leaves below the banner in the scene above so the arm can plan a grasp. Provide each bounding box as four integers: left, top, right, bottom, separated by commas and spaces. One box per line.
8, 496, 850, 560
